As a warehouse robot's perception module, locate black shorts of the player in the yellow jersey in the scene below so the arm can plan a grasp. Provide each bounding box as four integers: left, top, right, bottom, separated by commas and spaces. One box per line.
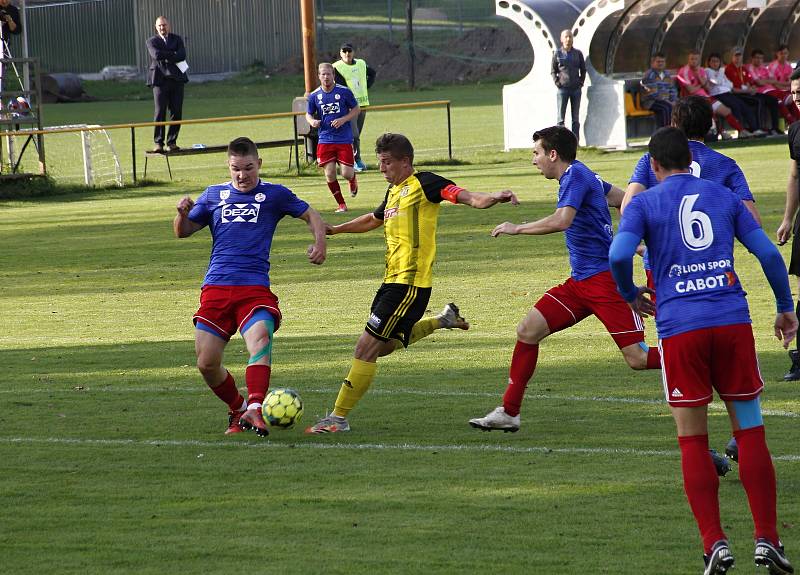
364, 284, 431, 347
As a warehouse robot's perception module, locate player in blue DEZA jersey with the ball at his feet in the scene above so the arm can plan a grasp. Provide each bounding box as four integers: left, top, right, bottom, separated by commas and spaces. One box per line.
173, 138, 325, 437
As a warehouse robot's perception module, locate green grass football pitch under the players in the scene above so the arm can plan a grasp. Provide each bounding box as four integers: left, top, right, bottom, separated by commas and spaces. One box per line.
0, 77, 800, 574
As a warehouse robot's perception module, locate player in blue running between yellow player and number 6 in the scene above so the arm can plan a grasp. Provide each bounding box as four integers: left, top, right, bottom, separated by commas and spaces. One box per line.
469, 126, 661, 432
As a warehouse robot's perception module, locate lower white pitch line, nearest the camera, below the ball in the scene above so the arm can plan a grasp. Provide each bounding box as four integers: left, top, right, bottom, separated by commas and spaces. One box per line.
0, 437, 800, 461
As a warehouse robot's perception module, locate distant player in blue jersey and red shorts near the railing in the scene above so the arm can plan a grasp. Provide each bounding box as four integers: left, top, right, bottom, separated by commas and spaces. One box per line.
306, 63, 361, 212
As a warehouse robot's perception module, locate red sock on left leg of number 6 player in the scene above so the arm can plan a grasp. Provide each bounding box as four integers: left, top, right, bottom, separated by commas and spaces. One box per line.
678, 435, 726, 554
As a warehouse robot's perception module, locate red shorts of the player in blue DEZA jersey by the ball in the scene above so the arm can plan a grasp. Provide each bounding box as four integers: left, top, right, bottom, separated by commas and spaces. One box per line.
192, 285, 281, 341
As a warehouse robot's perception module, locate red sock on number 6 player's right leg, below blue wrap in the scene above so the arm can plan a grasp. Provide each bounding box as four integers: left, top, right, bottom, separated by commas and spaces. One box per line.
733, 425, 778, 545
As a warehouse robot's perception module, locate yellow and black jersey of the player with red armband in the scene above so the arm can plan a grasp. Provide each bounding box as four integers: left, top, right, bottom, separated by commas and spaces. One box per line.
373, 172, 455, 288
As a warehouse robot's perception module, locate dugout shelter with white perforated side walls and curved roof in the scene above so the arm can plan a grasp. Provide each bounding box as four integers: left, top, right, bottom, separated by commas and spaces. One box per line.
495, 0, 800, 150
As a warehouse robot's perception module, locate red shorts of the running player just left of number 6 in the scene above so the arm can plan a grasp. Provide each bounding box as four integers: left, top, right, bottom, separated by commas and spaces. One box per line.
534, 271, 644, 349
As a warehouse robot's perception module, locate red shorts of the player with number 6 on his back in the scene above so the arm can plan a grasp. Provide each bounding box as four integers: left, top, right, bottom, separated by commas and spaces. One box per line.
659, 323, 764, 407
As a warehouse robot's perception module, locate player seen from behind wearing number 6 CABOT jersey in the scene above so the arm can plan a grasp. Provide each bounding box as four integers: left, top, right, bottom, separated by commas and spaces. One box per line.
609, 127, 797, 575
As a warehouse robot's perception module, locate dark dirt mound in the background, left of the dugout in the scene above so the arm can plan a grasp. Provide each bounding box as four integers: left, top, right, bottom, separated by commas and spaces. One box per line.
271, 26, 533, 86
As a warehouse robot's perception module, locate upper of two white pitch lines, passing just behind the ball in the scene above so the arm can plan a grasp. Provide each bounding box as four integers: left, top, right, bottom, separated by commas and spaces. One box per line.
0, 383, 800, 418
